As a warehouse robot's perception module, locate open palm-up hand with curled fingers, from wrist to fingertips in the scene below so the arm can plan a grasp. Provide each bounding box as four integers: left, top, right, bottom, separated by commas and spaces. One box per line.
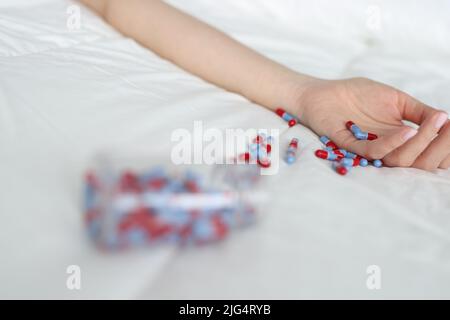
289, 78, 450, 171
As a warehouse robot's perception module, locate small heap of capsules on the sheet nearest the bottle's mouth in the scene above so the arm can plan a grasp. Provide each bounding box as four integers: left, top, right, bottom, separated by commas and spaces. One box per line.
239, 133, 274, 168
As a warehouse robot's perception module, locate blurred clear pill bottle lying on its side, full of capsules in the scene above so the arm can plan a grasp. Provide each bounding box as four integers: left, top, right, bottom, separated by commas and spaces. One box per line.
83, 149, 265, 250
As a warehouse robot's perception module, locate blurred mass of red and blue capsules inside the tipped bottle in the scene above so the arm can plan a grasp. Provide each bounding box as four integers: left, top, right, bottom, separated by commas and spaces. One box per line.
85, 166, 257, 250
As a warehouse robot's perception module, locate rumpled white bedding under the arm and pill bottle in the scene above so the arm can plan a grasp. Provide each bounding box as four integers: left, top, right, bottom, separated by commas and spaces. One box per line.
0, 0, 450, 299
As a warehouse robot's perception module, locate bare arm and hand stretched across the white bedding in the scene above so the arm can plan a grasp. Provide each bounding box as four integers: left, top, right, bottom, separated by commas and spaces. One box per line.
80, 0, 450, 171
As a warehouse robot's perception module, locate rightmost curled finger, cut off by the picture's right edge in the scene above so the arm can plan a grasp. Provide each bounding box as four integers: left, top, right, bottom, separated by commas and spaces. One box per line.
413, 121, 450, 171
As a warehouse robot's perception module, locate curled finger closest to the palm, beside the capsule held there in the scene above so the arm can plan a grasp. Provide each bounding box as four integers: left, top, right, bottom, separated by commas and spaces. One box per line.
333, 126, 417, 160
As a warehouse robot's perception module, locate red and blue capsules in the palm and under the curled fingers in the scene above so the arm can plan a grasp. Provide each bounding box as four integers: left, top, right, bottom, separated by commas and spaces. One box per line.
315, 121, 383, 175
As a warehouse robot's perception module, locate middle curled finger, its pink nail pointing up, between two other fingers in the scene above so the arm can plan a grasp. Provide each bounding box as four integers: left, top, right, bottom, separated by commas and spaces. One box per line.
384, 111, 448, 167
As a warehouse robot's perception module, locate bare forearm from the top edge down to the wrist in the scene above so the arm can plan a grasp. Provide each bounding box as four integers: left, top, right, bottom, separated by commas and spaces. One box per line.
82, 0, 311, 114
